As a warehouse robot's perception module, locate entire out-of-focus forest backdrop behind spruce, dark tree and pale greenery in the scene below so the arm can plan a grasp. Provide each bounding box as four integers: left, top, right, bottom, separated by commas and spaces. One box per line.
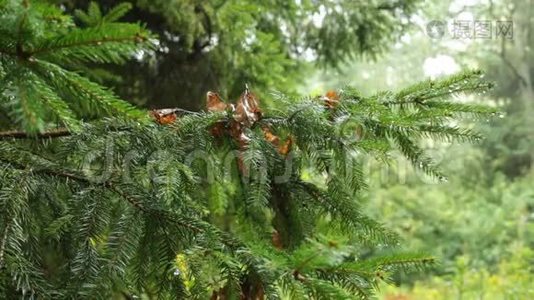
57, 0, 534, 300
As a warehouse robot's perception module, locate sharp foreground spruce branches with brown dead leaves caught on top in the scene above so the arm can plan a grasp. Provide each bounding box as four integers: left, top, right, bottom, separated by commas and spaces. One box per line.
0, 0, 498, 299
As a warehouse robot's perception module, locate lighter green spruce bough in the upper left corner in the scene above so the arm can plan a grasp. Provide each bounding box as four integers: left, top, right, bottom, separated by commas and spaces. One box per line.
0, 1, 151, 132
